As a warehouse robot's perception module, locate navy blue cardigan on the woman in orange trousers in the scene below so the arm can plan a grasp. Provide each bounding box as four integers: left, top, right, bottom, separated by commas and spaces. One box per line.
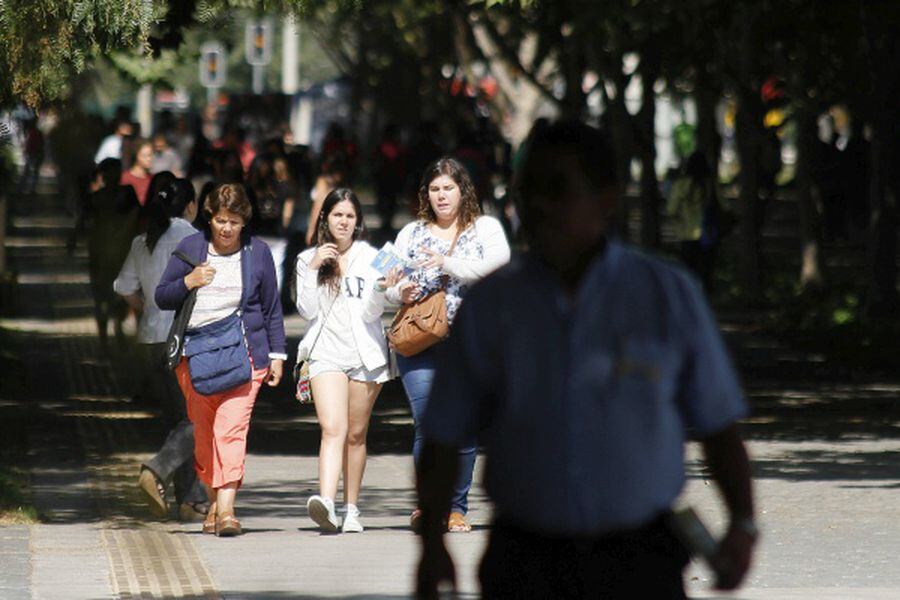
155, 232, 287, 369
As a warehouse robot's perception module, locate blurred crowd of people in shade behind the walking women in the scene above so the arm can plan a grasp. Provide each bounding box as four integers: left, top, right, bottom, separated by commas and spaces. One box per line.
52, 105, 514, 338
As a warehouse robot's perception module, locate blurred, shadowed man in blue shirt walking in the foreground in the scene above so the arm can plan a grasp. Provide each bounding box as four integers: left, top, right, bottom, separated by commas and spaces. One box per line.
418, 122, 757, 599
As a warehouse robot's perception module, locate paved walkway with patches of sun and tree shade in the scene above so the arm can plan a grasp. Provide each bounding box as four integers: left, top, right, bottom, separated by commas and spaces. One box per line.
0, 185, 900, 600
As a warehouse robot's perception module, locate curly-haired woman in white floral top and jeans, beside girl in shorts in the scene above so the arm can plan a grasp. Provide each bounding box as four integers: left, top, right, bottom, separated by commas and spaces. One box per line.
387, 158, 510, 531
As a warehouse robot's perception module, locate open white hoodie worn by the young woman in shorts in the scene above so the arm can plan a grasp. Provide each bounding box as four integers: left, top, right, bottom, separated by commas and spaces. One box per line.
297, 241, 388, 371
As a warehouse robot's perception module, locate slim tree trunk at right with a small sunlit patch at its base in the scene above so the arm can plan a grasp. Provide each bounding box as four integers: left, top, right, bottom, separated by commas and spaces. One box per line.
795, 106, 825, 291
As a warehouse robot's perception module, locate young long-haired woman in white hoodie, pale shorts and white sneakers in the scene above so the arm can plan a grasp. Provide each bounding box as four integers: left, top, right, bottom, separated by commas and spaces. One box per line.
297, 188, 399, 533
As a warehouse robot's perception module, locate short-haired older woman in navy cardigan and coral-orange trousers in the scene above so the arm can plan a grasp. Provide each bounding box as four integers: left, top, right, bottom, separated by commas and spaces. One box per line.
156, 184, 287, 536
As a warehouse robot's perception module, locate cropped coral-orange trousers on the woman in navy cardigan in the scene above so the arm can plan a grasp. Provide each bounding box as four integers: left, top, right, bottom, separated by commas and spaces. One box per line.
175, 359, 268, 489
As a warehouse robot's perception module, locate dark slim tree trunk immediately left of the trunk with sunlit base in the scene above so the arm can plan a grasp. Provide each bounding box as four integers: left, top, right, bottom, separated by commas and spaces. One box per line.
735, 90, 762, 302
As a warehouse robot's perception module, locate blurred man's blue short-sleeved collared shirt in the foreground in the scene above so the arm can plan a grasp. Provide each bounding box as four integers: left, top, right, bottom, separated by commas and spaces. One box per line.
424, 242, 747, 535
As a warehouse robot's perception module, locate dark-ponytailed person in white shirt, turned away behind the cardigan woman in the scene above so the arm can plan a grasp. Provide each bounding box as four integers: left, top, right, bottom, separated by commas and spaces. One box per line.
113, 179, 208, 520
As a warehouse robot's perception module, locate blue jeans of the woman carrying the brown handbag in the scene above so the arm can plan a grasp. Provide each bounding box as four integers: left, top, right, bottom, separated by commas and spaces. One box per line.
397, 347, 477, 514
